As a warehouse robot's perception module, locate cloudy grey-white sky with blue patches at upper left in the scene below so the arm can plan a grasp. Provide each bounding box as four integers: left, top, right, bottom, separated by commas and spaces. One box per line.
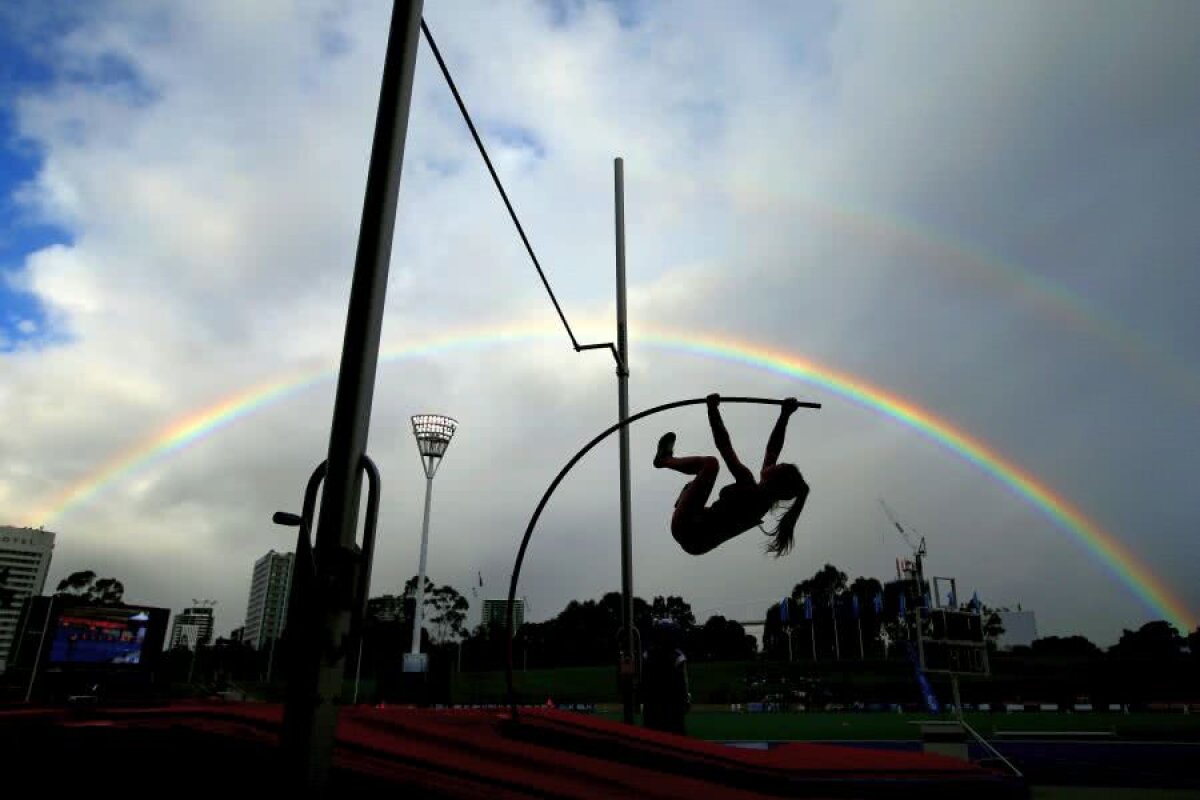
0, 0, 1200, 644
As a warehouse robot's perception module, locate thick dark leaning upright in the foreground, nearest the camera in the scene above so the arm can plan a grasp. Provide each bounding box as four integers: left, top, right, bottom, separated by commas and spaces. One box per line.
282, 0, 424, 790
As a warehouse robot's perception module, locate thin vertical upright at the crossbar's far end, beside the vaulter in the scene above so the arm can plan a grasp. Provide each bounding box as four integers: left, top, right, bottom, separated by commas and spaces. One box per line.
613, 158, 637, 724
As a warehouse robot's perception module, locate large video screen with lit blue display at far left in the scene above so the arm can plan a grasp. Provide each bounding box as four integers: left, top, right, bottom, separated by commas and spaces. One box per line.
49, 607, 151, 666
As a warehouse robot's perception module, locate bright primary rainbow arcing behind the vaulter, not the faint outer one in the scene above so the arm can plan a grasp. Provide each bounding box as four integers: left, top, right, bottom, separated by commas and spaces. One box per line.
16, 324, 1198, 631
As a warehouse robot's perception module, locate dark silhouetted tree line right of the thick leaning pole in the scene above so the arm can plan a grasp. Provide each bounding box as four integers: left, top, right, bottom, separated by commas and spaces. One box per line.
367, 564, 1200, 670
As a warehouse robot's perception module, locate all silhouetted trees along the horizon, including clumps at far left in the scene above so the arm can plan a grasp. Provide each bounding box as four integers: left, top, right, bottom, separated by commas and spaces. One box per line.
39, 564, 1200, 680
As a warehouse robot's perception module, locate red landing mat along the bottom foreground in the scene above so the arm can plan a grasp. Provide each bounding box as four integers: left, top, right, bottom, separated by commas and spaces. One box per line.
0, 704, 1027, 800
